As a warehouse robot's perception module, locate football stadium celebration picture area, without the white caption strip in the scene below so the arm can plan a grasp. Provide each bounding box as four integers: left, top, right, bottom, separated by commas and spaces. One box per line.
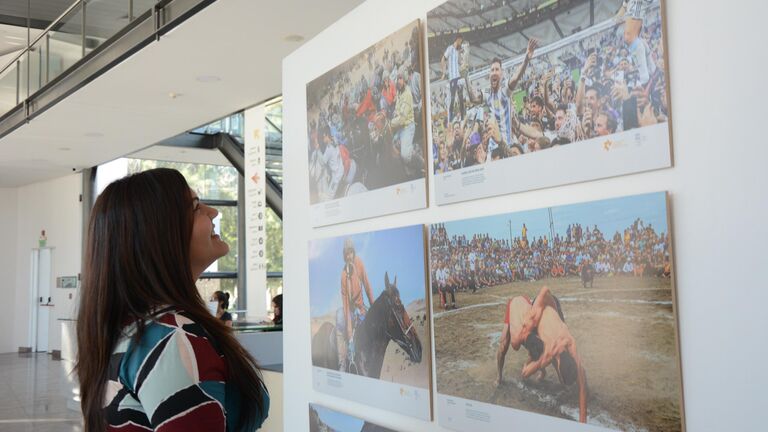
427, 0, 669, 173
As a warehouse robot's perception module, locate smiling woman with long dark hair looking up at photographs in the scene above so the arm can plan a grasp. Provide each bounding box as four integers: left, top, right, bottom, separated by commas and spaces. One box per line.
76, 169, 269, 432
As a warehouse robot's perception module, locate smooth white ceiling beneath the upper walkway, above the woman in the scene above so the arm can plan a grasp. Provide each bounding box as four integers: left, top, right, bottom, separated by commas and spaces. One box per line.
0, 0, 362, 187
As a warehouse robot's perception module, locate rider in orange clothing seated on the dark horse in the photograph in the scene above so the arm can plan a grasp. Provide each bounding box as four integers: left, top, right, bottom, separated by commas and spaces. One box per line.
336, 238, 374, 371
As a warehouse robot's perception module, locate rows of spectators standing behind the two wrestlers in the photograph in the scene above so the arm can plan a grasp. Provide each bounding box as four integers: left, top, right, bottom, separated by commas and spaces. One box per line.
429, 219, 671, 306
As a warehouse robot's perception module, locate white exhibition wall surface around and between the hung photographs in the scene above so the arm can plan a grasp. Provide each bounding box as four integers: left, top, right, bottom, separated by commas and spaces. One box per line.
283, 0, 768, 431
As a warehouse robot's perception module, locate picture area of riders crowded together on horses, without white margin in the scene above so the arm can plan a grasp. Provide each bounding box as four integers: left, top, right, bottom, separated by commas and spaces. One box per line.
307, 21, 426, 204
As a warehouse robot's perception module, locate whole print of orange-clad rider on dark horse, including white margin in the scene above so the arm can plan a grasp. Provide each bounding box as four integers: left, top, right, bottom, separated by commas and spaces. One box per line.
309, 225, 431, 420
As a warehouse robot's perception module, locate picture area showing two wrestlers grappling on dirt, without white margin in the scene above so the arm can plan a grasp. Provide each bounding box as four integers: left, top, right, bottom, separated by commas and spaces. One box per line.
429, 192, 683, 431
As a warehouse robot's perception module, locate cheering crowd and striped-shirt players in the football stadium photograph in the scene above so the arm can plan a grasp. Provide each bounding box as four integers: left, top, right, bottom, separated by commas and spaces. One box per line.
430, 0, 669, 173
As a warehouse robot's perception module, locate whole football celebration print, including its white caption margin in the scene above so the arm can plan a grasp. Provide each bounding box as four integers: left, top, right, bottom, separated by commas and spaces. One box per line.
427, 0, 672, 204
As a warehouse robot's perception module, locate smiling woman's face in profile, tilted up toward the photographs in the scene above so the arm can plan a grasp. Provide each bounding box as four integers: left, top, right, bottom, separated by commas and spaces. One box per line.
189, 191, 229, 270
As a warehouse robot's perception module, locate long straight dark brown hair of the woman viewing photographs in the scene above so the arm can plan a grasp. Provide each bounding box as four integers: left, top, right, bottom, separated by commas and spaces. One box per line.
76, 168, 265, 432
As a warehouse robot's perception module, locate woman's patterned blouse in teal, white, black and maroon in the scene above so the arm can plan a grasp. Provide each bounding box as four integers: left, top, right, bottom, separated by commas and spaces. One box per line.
107, 310, 229, 430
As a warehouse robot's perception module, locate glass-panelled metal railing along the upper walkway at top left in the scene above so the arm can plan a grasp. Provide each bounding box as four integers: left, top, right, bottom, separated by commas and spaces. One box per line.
0, 0, 216, 139
